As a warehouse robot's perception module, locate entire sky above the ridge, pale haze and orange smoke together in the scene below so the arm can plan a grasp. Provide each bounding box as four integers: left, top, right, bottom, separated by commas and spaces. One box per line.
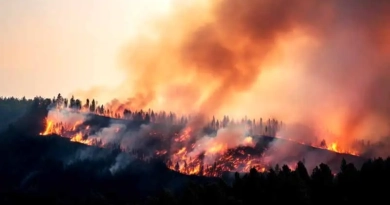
1, 0, 390, 148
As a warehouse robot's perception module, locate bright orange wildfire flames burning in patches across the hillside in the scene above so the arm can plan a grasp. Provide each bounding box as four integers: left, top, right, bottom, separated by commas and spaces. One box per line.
40, 108, 356, 176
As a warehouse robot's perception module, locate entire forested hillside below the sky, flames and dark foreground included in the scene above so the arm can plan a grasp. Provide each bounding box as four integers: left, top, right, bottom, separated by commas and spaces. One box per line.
0, 95, 390, 204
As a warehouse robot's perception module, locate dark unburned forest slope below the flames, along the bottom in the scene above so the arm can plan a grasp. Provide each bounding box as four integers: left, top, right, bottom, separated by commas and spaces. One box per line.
0, 98, 390, 205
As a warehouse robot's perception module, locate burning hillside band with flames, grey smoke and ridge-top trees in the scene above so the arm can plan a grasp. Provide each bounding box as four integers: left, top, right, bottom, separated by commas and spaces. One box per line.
35, 95, 361, 176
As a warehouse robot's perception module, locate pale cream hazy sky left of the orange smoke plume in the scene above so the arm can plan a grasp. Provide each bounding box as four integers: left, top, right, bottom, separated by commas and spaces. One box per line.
0, 0, 169, 97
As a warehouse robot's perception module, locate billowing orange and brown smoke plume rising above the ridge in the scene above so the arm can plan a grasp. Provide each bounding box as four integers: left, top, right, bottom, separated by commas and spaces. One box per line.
78, 0, 390, 150
